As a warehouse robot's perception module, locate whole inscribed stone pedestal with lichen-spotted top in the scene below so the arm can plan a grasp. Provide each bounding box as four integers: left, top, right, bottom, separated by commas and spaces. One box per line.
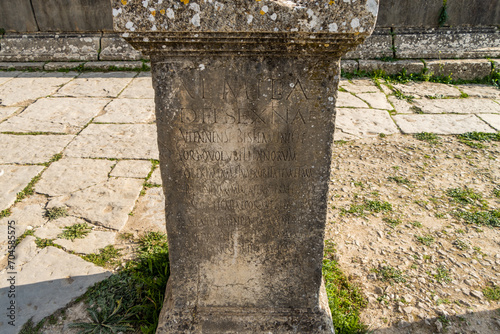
112, 0, 378, 334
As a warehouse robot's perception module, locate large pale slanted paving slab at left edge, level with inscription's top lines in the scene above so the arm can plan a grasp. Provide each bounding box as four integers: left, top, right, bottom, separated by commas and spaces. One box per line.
0, 98, 109, 134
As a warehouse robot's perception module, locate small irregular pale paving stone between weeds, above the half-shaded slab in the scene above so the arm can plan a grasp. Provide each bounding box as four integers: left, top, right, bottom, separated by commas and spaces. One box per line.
54, 231, 116, 254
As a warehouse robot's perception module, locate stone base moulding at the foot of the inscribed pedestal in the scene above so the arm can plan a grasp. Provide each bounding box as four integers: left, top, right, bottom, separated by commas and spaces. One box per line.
156, 281, 335, 334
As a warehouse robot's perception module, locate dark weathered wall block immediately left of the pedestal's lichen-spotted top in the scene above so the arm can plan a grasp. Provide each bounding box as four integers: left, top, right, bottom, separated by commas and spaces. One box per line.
31, 0, 112, 31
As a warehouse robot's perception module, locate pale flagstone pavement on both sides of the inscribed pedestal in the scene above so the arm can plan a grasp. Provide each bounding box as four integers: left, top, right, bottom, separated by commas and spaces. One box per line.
0, 72, 500, 333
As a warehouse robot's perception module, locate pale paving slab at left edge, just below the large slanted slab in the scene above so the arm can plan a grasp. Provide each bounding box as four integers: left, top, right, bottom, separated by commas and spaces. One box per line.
0, 134, 74, 164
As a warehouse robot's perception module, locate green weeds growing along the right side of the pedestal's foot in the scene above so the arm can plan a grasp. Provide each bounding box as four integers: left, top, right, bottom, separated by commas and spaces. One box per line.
323, 241, 368, 334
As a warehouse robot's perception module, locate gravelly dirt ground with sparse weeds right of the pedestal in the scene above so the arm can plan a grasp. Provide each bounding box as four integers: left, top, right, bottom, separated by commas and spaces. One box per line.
327, 135, 500, 334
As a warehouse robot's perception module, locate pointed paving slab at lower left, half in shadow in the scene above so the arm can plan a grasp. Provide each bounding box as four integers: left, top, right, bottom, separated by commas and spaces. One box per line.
0, 242, 111, 332
